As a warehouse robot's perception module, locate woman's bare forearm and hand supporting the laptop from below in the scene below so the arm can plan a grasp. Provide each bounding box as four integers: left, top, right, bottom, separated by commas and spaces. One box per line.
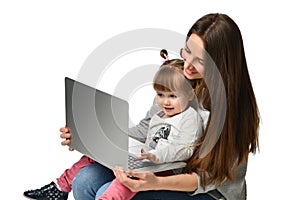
114, 168, 198, 192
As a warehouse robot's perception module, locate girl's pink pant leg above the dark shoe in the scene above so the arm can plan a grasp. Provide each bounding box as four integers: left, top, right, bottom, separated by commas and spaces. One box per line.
56, 156, 95, 192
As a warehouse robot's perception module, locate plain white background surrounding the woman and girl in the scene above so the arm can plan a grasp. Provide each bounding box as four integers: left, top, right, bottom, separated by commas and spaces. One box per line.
0, 0, 300, 200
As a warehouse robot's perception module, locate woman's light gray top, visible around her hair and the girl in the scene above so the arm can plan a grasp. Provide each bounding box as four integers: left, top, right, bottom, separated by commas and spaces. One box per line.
129, 100, 247, 200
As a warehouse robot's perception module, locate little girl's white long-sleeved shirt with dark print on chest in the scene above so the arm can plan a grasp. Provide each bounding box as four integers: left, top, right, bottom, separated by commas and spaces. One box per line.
145, 107, 202, 163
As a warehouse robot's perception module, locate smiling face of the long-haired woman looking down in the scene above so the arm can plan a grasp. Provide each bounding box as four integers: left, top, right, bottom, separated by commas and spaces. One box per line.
180, 33, 205, 80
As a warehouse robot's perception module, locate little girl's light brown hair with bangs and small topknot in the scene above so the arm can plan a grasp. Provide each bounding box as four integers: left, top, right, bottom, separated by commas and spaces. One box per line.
153, 49, 195, 99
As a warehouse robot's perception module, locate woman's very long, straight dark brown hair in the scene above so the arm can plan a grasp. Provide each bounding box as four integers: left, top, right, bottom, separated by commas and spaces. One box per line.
187, 14, 260, 187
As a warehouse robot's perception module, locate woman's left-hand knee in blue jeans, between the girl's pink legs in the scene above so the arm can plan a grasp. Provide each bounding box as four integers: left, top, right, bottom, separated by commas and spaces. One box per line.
73, 162, 115, 200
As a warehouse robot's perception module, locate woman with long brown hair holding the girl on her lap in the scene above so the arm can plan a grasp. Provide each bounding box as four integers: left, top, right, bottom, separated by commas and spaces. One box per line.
61, 14, 259, 200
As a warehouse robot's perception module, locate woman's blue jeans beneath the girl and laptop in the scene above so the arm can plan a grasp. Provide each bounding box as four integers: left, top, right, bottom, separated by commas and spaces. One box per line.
72, 163, 213, 200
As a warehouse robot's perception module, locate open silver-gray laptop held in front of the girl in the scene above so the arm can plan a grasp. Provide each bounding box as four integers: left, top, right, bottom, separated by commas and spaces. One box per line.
65, 77, 186, 172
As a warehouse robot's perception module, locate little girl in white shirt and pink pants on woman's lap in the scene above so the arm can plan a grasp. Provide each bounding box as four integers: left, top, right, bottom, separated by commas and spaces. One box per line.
98, 50, 202, 200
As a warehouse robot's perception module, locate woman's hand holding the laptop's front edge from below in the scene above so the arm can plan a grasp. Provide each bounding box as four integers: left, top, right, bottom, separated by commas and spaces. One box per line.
113, 167, 158, 192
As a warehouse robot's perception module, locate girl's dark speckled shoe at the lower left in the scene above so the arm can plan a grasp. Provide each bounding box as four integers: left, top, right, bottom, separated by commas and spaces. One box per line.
24, 182, 69, 200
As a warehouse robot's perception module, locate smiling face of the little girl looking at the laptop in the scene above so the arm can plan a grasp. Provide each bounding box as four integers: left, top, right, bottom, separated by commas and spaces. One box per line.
156, 91, 189, 118
